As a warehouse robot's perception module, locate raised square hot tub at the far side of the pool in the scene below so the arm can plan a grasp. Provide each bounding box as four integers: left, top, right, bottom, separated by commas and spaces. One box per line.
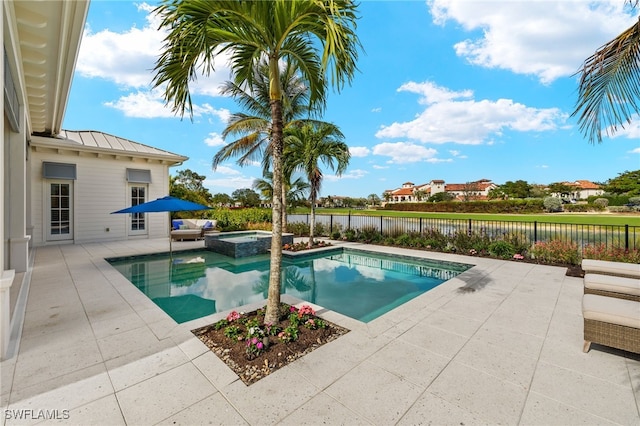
204, 231, 293, 258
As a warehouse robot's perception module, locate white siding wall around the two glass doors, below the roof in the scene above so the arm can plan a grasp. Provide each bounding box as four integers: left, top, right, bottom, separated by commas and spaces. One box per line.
31, 151, 169, 246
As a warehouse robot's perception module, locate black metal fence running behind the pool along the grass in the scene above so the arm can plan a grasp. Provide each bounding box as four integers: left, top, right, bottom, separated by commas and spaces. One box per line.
288, 214, 640, 255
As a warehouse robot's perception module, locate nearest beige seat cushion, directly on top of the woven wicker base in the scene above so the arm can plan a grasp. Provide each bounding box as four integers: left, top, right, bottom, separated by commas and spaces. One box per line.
582, 294, 640, 329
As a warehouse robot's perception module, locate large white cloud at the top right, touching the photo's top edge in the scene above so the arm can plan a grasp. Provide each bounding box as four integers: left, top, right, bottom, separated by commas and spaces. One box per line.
427, 0, 637, 84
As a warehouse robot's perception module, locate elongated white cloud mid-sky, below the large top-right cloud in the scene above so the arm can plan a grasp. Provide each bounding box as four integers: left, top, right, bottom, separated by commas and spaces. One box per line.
376, 81, 567, 145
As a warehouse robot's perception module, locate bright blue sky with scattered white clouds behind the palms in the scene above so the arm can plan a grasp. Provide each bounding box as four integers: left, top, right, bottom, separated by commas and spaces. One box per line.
63, 0, 640, 197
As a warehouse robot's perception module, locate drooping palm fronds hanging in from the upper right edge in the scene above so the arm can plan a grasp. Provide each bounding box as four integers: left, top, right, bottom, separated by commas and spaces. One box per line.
572, 0, 640, 143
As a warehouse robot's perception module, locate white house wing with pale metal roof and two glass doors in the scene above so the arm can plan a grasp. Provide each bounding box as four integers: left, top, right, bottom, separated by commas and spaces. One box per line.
29, 130, 187, 246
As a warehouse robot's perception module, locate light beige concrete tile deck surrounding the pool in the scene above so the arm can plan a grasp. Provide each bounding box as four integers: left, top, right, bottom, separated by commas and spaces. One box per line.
0, 238, 640, 425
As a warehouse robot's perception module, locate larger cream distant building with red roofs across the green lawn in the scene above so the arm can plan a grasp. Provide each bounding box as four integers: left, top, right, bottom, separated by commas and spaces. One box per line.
383, 179, 498, 203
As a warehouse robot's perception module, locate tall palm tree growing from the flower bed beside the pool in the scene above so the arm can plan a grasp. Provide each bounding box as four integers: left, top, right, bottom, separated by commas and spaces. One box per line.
153, 0, 360, 324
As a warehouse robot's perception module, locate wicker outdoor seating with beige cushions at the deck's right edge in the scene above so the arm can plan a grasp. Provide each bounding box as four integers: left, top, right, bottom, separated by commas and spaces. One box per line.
582, 259, 640, 354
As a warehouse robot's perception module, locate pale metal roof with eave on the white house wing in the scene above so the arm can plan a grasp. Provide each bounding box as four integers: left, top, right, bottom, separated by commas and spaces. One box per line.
31, 130, 189, 163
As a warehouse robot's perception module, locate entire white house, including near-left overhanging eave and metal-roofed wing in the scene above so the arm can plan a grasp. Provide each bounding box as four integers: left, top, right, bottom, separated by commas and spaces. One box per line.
0, 0, 186, 359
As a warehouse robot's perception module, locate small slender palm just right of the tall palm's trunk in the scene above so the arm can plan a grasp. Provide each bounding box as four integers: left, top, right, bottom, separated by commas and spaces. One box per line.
285, 123, 351, 247
